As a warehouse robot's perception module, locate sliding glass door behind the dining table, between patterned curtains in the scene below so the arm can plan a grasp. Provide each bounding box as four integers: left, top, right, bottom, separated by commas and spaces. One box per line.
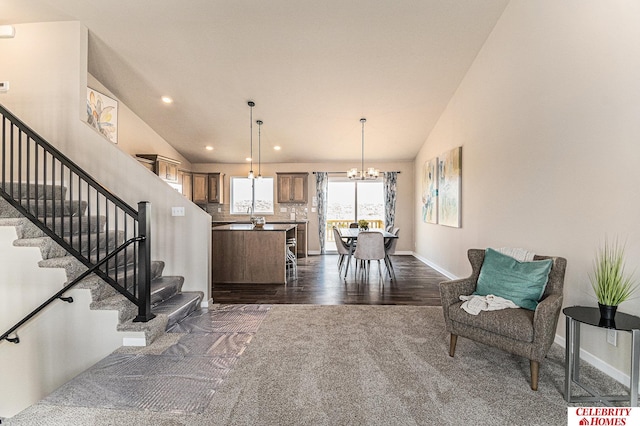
325, 177, 384, 251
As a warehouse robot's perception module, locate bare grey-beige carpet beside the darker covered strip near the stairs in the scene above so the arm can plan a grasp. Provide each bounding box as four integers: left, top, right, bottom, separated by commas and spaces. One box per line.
8, 305, 622, 426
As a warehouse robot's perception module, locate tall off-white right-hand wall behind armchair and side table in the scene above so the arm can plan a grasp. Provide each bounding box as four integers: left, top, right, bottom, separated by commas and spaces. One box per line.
414, 0, 640, 382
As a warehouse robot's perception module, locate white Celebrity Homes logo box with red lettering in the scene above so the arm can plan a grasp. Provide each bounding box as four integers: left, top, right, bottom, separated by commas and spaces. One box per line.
567, 407, 640, 426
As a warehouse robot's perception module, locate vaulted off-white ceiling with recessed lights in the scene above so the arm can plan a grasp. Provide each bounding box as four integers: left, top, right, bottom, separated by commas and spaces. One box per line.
0, 0, 508, 163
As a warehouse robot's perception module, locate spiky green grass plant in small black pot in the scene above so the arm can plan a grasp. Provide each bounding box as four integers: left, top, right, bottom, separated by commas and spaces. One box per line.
589, 239, 638, 320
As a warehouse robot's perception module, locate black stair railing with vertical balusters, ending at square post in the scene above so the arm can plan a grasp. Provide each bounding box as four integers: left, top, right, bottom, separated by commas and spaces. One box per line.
0, 105, 154, 341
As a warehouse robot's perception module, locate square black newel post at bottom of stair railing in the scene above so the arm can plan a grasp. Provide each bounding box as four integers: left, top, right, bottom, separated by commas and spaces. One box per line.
133, 201, 155, 322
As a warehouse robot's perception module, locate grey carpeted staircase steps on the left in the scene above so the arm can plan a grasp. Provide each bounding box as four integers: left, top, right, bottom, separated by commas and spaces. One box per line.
0, 183, 204, 345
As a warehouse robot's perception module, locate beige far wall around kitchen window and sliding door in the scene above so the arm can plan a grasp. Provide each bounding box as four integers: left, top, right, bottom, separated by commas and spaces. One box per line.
193, 162, 414, 253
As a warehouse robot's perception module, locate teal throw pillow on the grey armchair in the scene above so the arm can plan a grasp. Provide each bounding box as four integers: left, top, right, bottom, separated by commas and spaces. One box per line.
473, 248, 553, 311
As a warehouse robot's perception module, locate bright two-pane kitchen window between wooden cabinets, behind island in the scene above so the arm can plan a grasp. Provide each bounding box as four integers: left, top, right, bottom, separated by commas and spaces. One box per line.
231, 177, 273, 214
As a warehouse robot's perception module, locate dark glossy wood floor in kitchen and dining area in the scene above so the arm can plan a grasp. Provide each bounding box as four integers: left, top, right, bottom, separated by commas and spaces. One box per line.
212, 254, 447, 306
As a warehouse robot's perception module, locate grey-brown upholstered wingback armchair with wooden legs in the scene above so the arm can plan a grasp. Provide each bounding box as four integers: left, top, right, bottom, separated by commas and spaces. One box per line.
440, 249, 567, 391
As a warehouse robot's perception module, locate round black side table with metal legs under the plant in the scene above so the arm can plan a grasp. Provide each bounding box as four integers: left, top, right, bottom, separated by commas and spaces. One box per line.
562, 306, 640, 407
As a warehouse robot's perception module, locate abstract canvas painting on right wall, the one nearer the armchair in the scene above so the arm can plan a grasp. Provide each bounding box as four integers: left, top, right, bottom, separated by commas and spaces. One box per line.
438, 146, 462, 228
